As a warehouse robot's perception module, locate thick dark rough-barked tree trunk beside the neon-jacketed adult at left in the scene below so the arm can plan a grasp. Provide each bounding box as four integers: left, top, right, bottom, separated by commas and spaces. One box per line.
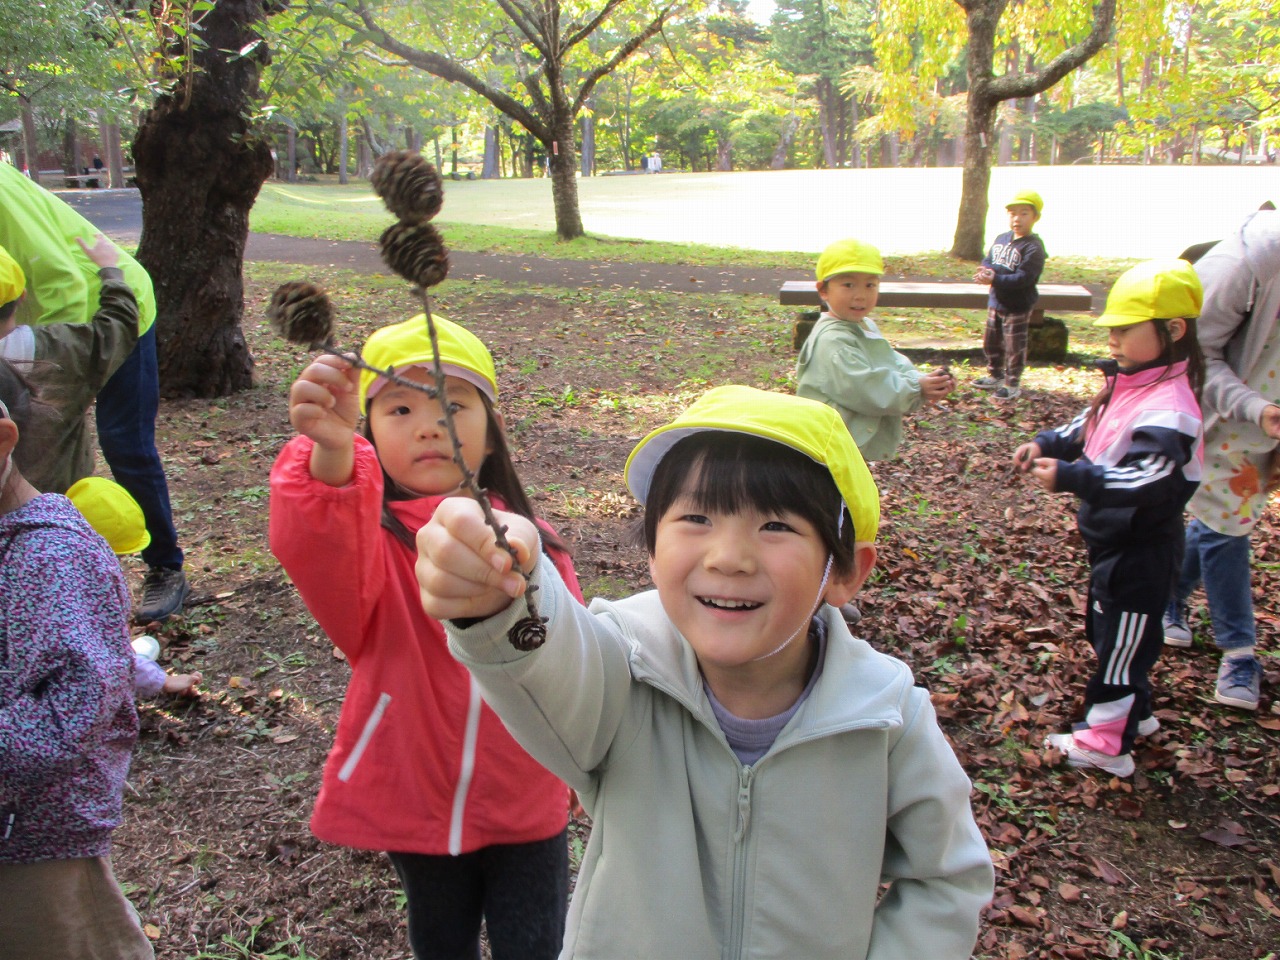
133, 0, 271, 397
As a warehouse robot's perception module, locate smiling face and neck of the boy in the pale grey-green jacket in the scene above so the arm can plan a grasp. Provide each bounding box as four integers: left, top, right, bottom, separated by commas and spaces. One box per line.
649, 497, 847, 717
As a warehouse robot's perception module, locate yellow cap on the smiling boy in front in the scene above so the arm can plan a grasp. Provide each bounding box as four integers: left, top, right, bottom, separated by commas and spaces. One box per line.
625, 387, 879, 543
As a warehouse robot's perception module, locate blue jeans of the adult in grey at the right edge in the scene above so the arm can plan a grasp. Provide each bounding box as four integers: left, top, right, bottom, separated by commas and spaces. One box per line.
1165, 520, 1257, 650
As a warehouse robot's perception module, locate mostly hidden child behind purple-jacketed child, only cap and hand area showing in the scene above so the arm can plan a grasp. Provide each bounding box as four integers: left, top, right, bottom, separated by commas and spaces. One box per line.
67, 476, 202, 700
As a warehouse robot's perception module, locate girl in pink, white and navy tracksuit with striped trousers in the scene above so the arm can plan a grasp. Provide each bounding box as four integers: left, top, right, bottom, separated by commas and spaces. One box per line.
1014, 260, 1204, 777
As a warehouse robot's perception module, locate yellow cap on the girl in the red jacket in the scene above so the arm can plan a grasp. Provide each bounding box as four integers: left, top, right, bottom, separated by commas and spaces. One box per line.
360, 314, 498, 413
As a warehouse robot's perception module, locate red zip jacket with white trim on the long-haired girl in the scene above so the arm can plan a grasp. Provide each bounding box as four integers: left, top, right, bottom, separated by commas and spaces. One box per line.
271, 436, 581, 855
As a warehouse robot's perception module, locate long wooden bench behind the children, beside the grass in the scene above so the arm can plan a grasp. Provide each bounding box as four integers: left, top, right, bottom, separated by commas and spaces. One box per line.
778, 280, 1093, 360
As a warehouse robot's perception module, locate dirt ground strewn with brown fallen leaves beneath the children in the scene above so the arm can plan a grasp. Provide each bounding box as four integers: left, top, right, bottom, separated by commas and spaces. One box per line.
114, 265, 1280, 960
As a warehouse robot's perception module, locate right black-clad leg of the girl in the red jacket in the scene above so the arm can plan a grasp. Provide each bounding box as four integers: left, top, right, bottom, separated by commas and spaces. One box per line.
480, 831, 568, 960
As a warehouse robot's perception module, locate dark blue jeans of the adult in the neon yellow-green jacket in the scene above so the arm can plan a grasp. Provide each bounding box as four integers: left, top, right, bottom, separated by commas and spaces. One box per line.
96, 326, 183, 570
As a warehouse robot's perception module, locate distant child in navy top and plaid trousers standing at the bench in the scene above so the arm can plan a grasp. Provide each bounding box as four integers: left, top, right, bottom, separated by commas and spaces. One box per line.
973, 189, 1044, 399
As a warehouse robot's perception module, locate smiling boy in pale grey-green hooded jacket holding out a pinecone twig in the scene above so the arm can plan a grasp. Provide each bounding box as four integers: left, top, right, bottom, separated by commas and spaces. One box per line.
419, 387, 993, 960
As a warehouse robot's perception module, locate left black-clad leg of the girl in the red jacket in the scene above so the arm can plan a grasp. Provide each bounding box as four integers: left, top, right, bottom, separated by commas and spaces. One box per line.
388, 852, 484, 960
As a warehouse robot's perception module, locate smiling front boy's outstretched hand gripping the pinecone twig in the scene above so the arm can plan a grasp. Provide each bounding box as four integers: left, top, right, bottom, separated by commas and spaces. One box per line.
416, 497, 539, 620
